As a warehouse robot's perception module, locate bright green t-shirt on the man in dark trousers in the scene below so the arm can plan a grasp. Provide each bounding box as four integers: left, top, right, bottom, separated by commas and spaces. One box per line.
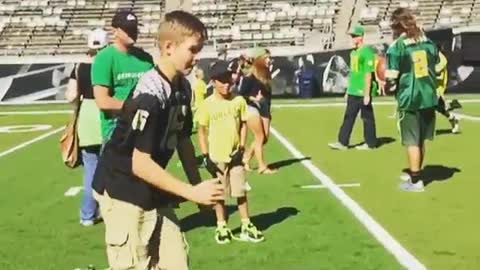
347, 46, 378, 96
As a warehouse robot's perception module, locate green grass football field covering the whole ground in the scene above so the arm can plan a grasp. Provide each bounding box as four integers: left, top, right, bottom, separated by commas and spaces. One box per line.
0, 96, 480, 270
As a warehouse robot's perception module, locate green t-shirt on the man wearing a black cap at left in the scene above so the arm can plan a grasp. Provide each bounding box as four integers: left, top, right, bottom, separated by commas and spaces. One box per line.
91, 45, 153, 142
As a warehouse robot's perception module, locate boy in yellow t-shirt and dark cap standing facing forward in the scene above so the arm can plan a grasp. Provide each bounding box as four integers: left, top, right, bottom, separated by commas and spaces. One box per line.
197, 61, 264, 244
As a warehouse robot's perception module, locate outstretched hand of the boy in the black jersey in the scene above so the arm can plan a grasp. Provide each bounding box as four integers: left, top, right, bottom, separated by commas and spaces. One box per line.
187, 179, 224, 205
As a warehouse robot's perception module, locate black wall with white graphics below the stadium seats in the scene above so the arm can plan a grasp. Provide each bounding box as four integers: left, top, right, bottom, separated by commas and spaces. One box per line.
0, 50, 480, 103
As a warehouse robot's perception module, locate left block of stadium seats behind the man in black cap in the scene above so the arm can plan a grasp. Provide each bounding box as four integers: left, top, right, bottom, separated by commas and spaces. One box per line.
0, 0, 165, 56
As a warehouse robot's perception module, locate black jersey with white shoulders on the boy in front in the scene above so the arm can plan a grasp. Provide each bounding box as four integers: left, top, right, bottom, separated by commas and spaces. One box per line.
93, 69, 193, 210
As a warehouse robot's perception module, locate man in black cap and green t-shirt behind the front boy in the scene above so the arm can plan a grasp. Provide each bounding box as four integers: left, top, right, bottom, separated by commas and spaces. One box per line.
92, 9, 153, 143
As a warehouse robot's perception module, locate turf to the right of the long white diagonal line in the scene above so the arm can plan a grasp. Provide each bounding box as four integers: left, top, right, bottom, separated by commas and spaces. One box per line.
274, 99, 480, 269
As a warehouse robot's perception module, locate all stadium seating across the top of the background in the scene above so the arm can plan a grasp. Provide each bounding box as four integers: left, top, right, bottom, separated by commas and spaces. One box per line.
0, 0, 480, 56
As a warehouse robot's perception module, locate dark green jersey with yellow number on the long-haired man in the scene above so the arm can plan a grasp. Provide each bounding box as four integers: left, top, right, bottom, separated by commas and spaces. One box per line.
387, 35, 444, 111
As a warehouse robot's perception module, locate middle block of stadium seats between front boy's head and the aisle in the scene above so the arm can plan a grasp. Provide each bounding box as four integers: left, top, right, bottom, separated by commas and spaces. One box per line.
192, 0, 339, 49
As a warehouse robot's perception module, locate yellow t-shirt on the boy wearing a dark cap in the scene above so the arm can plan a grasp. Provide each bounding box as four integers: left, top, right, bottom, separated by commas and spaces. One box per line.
197, 94, 247, 163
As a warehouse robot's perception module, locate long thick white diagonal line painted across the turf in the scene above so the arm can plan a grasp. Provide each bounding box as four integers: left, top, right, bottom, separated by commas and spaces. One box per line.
271, 128, 426, 270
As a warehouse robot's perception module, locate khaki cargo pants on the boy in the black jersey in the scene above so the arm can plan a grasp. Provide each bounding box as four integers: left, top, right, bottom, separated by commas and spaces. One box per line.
94, 192, 188, 270
